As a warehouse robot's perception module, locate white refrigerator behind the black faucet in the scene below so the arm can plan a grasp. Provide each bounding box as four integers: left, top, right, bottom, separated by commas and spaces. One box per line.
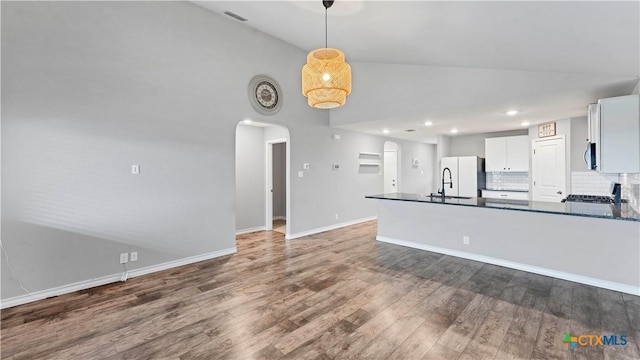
438, 156, 486, 197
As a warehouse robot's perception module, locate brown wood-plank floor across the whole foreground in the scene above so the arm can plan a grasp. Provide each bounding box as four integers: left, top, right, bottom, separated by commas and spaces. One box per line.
1, 222, 640, 360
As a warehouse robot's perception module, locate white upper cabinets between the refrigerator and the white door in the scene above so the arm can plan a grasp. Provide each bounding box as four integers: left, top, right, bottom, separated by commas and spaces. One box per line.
484, 135, 529, 172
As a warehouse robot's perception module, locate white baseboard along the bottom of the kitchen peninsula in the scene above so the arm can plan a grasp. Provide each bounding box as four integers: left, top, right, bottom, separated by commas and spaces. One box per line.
376, 236, 640, 295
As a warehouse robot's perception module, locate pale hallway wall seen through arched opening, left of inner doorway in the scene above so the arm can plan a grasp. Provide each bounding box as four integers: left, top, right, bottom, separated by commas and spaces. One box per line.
235, 124, 266, 231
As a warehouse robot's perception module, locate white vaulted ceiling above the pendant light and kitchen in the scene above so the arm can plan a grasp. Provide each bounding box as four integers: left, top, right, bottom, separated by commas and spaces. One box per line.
196, 0, 640, 142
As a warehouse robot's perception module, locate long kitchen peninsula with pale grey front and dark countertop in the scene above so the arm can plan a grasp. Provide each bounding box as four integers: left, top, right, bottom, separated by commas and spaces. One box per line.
367, 193, 640, 295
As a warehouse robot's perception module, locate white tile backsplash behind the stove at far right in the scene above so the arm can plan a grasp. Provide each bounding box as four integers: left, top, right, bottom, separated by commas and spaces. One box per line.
571, 171, 640, 212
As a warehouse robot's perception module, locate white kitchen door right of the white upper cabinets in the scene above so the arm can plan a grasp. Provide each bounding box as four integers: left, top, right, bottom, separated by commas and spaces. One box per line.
532, 137, 566, 202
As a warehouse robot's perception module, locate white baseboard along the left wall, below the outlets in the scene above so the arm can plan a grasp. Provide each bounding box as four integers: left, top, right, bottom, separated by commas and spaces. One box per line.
0, 246, 238, 309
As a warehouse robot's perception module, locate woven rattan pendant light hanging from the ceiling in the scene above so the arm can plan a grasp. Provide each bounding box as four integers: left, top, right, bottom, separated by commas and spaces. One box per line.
302, 0, 351, 109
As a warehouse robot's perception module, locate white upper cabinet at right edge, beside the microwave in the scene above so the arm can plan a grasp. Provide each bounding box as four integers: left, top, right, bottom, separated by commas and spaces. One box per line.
595, 95, 640, 173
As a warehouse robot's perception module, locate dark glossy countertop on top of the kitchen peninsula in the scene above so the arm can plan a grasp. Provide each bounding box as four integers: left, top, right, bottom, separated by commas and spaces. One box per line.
365, 193, 640, 222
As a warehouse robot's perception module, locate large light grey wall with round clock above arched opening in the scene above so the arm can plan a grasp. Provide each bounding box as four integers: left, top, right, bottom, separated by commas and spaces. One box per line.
1, 2, 436, 300
